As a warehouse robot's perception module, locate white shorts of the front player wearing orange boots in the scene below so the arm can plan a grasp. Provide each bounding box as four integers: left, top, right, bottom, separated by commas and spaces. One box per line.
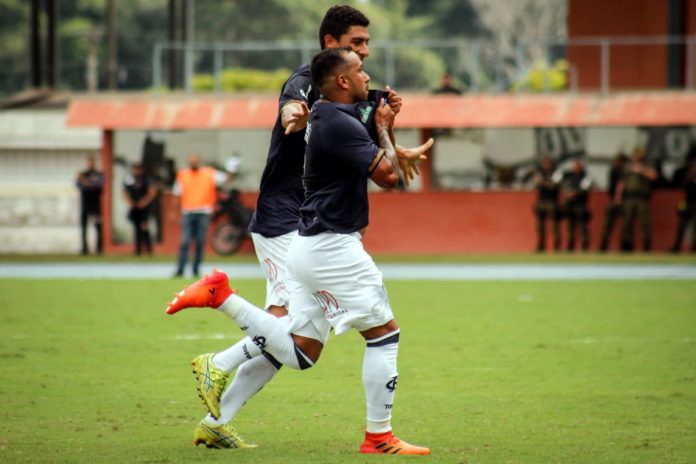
287, 232, 394, 343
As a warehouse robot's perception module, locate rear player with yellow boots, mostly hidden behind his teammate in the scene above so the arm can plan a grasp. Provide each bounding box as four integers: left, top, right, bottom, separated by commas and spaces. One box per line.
182, 6, 408, 448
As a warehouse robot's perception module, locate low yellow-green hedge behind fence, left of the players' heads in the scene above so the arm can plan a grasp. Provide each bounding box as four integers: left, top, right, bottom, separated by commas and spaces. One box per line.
192, 68, 291, 92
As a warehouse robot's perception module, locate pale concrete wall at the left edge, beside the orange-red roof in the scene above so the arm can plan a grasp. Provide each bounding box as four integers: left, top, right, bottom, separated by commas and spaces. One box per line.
0, 109, 101, 254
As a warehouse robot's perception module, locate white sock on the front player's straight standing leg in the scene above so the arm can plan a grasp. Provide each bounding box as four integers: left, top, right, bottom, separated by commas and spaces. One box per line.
363, 330, 399, 433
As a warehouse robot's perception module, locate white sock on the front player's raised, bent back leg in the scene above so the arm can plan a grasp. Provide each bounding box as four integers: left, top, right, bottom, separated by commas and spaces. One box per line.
218, 295, 313, 369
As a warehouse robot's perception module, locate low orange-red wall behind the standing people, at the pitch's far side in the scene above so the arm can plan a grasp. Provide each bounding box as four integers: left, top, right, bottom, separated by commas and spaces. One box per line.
135, 190, 681, 255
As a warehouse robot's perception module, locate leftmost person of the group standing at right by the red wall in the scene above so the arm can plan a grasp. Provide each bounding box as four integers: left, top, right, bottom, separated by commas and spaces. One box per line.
534, 156, 561, 252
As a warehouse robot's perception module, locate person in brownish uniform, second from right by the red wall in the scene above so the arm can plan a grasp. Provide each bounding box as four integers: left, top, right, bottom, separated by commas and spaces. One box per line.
618, 149, 657, 252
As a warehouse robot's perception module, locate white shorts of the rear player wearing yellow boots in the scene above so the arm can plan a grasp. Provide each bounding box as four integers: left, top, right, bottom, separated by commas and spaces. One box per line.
251, 231, 297, 309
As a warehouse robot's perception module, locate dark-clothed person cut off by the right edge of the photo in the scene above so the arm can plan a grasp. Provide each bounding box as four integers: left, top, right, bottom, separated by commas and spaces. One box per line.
670, 150, 696, 253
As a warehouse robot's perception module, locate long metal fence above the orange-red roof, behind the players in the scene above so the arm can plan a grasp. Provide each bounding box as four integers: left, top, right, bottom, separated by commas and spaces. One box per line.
152, 36, 696, 93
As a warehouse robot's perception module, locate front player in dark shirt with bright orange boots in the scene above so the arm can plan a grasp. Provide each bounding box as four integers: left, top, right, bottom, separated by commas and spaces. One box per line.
167, 48, 432, 455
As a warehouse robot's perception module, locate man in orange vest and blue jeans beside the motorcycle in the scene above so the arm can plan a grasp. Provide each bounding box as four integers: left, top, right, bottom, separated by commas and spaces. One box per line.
174, 154, 216, 277
